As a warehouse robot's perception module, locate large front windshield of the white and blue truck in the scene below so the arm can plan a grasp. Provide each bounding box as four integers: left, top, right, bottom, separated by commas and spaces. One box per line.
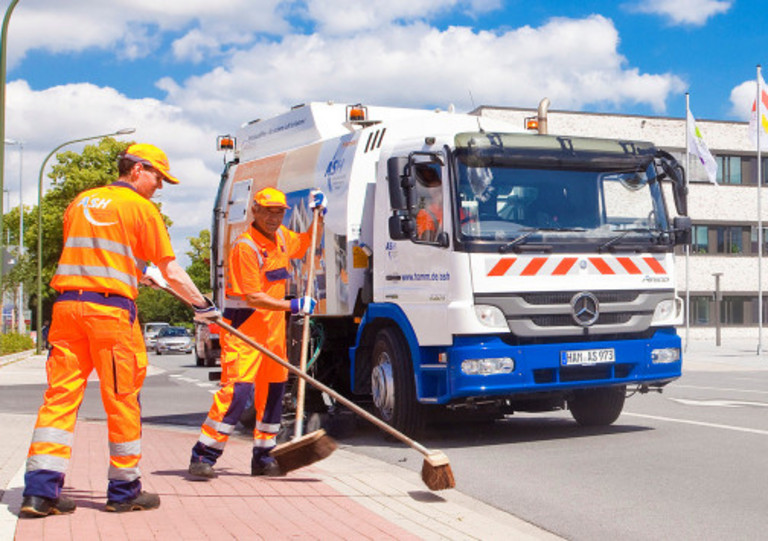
455, 132, 668, 249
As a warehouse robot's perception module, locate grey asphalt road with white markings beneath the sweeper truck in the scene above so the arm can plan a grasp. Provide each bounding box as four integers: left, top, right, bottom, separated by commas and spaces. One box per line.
6, 346, 768, 540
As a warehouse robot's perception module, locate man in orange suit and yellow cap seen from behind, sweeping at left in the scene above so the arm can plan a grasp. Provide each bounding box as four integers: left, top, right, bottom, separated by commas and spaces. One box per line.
20, 144, 219, 517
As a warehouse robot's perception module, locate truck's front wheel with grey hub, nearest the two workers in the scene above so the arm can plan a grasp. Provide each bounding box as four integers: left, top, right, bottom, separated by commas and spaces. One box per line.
371, 328, 426, 435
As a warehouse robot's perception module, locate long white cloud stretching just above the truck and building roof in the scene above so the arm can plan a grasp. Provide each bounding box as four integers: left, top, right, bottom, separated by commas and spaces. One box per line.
162, 16, 685, 129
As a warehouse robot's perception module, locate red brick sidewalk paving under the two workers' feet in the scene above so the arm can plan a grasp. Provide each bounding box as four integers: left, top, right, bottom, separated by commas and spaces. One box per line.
16, 421, 417, 541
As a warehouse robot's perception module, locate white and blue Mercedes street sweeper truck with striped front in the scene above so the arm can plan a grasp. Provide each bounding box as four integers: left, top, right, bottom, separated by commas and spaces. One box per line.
202, 103, 691, 433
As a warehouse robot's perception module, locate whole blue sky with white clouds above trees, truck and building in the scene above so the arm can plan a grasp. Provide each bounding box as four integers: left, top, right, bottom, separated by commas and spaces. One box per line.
0, 0, 768, 262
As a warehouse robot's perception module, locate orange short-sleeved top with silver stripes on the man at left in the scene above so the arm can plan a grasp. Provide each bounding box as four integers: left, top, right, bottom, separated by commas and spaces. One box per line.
51, 181, 175, 299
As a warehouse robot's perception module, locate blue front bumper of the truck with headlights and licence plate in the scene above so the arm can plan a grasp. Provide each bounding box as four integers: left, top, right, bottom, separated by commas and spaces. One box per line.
415, 329, 682, 403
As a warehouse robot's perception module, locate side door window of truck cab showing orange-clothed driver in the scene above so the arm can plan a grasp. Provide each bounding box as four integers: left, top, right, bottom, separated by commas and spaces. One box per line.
411, 163, 444, 242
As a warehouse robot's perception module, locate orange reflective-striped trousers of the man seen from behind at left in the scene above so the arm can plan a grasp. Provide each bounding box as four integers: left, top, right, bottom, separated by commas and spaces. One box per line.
24, 299, 147, 501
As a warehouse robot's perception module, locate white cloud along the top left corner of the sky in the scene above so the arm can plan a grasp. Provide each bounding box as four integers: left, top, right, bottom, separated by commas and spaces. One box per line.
8, 0, 291, 67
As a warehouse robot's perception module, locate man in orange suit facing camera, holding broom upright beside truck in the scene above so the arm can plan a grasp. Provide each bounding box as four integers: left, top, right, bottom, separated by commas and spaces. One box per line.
189, 188, 326, 479
